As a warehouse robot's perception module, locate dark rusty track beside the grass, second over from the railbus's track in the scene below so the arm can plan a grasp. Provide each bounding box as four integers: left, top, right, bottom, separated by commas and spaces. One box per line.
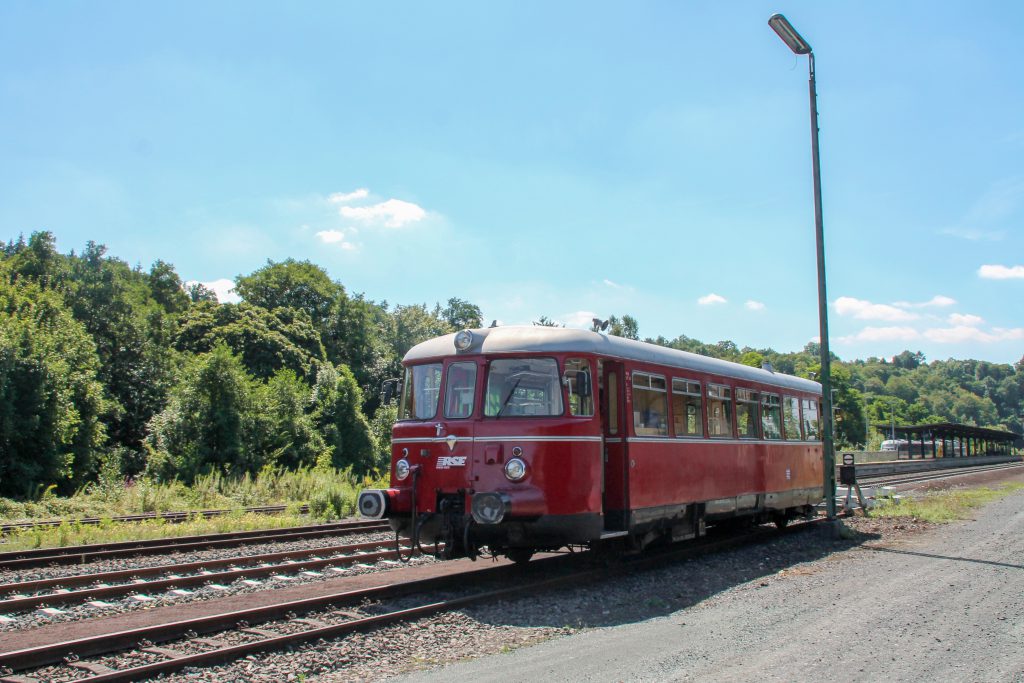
0, 520, 390, 570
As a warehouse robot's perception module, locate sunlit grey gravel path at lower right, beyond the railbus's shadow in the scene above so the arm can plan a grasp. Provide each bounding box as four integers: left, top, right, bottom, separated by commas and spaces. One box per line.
395, 485, 1024, 683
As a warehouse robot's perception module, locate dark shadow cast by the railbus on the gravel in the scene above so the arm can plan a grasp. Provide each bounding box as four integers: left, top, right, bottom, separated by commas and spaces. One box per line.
465, 528, 881, 629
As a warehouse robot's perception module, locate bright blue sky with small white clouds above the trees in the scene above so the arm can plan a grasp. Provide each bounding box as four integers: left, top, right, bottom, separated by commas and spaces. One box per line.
0, 0, 1024, 361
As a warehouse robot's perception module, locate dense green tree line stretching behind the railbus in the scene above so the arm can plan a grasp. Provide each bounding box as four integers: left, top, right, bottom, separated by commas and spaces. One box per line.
0, 232, 1024, 497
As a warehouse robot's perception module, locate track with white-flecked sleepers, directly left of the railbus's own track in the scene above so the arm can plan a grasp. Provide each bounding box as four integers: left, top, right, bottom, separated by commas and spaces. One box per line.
0, 543, 411, 614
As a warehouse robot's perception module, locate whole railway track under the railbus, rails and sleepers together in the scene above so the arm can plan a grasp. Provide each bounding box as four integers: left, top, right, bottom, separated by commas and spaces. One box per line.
0, 521, 815, 683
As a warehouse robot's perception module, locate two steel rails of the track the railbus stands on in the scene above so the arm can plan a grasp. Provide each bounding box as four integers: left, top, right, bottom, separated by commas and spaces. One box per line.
0, 520, 818, 681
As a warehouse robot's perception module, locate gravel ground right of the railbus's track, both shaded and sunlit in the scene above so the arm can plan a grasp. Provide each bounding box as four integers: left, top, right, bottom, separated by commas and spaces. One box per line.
149, 481, 1024, 683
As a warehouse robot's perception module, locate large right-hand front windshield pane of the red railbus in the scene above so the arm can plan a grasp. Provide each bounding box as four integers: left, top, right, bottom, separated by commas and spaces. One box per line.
483, 358, 562, 418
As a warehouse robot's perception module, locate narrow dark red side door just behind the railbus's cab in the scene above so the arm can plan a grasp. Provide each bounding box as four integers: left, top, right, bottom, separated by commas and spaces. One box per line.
601, 360, 630, 531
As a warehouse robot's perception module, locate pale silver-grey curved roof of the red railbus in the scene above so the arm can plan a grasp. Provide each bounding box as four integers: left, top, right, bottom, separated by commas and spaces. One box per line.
402, 326, 821, 395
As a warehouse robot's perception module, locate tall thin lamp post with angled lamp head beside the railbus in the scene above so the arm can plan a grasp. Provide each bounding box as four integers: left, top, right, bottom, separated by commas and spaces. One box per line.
768, 14, 836, 521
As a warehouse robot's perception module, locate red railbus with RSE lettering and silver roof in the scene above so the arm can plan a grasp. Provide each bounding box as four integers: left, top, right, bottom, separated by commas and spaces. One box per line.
358, 327, 823, 560
